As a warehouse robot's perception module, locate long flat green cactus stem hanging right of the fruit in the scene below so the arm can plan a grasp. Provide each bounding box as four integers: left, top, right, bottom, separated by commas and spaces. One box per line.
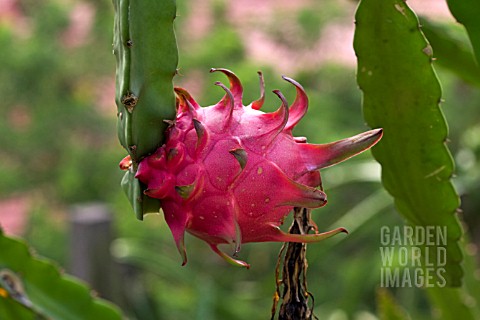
354, 0, 463, 286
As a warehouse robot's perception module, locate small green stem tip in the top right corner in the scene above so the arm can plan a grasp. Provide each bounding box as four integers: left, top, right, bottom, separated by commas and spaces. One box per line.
447, 0, 480, 65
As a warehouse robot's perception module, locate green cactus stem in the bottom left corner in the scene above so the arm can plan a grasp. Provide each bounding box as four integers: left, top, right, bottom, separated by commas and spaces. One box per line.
0, 230, 122, 320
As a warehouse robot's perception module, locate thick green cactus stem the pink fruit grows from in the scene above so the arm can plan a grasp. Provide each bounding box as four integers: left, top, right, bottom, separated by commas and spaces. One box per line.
113, 0, 178, 218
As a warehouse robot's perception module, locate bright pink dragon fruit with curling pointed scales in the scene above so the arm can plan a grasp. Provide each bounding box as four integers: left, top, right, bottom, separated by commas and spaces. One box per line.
120, 69, 382, 267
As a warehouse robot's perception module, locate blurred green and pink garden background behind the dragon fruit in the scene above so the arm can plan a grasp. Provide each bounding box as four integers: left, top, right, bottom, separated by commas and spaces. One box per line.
0, 0, 480, 320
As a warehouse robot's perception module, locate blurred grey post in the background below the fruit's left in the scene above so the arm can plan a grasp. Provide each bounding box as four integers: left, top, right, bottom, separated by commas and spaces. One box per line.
69, 203, 121, 303
